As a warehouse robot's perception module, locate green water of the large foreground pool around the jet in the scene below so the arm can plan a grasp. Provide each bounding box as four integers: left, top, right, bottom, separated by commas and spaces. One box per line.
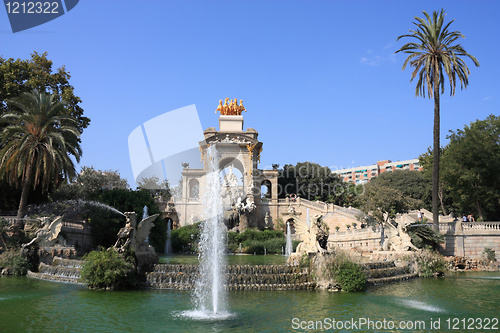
0, 272, 500, 332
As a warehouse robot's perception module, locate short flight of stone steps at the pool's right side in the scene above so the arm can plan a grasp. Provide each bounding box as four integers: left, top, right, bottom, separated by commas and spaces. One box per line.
361, 261, 418, 285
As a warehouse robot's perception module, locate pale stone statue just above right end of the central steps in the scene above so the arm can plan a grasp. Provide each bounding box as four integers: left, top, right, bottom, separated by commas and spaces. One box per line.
292, 214, 328, 254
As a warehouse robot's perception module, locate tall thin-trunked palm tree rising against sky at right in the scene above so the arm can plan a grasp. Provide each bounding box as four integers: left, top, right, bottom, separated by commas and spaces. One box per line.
396, 9, 479, 231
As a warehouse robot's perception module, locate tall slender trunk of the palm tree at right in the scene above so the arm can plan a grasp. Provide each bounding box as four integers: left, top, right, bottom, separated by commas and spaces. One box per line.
432, 68, 440, 231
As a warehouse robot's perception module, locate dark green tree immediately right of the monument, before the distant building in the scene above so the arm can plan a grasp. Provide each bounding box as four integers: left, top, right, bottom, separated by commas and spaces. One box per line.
278, 162, 345, 202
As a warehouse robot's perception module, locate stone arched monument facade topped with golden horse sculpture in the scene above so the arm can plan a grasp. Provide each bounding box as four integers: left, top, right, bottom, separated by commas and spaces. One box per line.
175, 98, 278, 231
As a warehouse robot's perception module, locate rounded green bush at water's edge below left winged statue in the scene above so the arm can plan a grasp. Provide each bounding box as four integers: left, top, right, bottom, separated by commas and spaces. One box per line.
81, 248, 137, 289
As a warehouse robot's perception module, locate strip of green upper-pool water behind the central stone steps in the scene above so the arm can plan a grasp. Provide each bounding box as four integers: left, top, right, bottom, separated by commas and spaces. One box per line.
160, 254, 287, 265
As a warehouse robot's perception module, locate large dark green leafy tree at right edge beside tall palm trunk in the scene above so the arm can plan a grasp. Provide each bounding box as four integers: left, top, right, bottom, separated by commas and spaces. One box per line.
422, 115, 500, 220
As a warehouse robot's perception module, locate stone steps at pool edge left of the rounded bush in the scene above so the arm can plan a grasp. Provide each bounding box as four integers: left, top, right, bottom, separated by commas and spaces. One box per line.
28, 257, 82, 284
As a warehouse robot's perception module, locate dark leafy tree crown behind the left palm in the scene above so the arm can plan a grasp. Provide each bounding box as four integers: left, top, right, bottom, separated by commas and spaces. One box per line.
0, 52, 90, 134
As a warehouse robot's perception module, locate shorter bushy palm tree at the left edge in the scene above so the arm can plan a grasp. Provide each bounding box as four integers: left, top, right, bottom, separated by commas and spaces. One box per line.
0, 90, 82, 224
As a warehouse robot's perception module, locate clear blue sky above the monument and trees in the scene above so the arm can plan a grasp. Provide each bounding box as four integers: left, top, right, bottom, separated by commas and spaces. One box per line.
0, 0, 500, 187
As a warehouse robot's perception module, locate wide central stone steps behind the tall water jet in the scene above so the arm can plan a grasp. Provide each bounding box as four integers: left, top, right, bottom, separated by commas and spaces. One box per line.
145, 264, 315, 290
